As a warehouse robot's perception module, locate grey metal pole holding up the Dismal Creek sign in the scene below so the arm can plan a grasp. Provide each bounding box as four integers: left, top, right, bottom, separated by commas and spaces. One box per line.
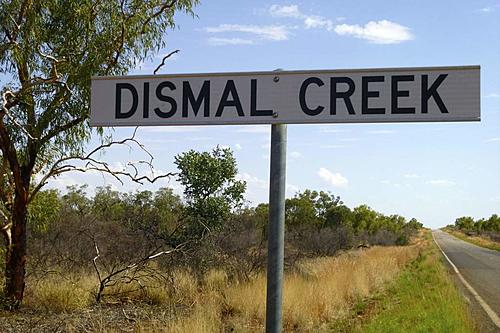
266, 124, 286, 333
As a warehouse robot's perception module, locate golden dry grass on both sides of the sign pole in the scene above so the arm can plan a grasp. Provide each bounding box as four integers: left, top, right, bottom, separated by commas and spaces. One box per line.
17, 244, 422, 333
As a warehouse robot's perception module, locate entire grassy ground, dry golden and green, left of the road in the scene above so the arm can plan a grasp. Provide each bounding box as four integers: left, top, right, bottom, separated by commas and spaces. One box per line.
0, 224, 473, 332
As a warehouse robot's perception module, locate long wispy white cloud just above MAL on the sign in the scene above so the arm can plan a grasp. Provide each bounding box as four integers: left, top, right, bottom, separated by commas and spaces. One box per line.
205, 24, 290, 41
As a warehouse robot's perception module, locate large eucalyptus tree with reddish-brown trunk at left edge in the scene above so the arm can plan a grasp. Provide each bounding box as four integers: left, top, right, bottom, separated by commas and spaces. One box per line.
0, 0, 198, 308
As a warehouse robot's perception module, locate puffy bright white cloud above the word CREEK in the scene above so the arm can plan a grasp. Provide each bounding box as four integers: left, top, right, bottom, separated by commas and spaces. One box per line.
335, 20, 414, 44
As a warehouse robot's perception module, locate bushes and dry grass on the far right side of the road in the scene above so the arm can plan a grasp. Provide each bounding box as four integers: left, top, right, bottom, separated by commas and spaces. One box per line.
444, 214, 500, 251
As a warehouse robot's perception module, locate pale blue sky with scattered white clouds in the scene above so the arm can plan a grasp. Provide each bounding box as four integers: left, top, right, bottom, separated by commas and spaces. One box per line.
50, 0, 500, 227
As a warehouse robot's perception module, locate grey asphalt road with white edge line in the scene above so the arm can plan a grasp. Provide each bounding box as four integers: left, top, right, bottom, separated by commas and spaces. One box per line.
433, 230, 500, 330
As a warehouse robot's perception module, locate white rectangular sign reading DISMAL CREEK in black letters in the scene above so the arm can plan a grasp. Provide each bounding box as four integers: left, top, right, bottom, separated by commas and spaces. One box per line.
90, 66, 480, 126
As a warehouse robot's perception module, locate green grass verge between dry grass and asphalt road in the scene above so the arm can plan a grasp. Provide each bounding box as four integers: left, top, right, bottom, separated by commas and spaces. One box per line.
355, 233, 477, 333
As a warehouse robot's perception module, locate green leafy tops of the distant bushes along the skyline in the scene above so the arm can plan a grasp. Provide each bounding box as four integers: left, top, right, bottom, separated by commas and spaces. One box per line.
29, 185, 422, 241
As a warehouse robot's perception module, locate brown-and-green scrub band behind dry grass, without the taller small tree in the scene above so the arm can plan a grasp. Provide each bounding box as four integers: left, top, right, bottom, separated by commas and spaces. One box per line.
20, 182, 421, 301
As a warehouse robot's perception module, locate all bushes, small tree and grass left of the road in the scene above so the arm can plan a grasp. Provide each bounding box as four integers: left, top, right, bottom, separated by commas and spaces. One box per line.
0, 148, 478, 332
